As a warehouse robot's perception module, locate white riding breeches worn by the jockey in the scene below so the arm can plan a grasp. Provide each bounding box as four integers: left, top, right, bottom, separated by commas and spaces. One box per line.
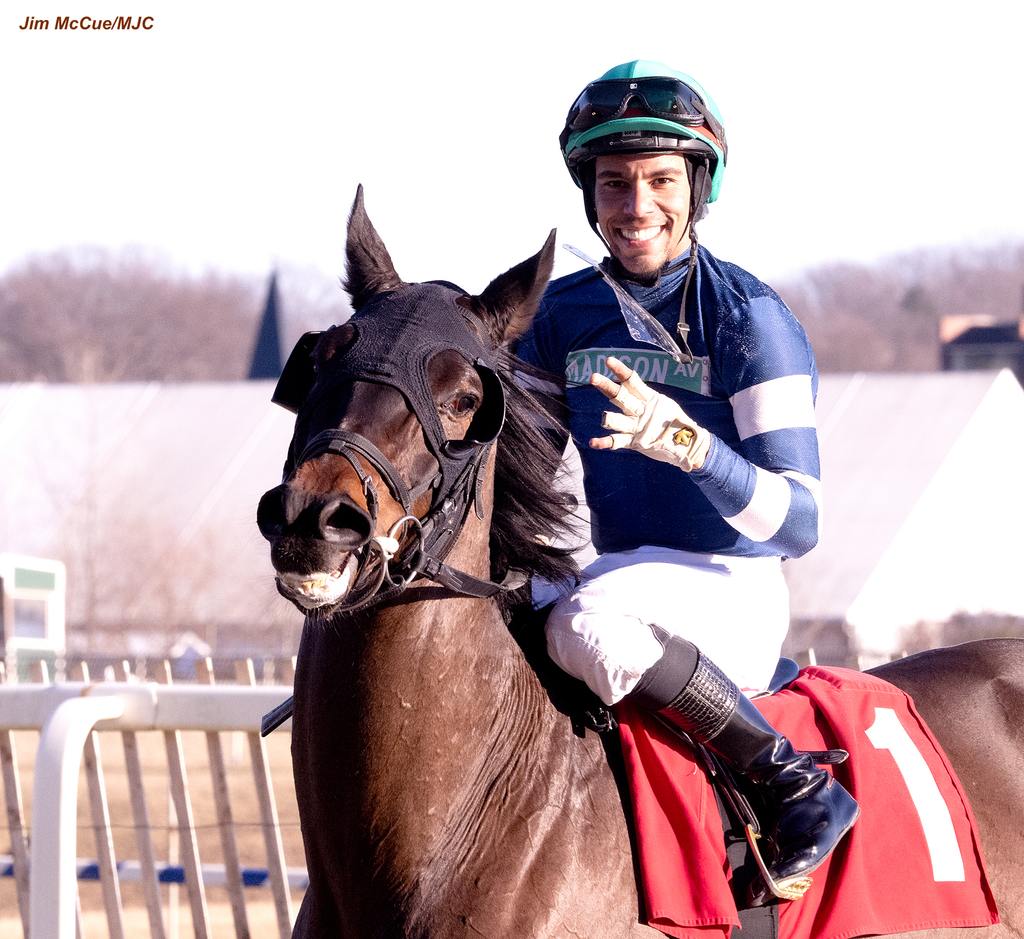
546, 547, 790, 705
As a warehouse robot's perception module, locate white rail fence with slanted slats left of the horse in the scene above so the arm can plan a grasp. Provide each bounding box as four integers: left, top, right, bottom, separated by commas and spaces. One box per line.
0, 659, 306, 939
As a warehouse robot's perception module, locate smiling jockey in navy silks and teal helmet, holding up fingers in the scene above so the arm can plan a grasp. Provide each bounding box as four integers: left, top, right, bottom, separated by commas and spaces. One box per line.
517, 61, 859, 897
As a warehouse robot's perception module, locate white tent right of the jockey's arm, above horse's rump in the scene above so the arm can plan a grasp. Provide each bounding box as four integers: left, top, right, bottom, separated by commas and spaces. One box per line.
784, 371, 1024, 651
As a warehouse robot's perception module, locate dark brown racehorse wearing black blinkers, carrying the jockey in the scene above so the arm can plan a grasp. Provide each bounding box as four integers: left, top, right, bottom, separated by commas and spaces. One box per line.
257, 188, 1024, 939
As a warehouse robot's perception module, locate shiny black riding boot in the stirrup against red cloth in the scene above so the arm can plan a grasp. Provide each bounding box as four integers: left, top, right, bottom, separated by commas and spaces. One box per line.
633, 634, 860, 896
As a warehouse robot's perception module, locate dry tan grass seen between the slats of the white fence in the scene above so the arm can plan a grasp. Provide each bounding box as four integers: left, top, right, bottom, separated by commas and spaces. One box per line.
0, 730, 305, 939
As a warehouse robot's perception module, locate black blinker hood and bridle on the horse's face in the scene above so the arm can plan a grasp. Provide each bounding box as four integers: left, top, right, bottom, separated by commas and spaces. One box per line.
264, 284, 526, 616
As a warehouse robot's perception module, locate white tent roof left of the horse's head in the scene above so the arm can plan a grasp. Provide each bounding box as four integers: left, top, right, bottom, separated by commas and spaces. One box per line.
0, 382, 298, 627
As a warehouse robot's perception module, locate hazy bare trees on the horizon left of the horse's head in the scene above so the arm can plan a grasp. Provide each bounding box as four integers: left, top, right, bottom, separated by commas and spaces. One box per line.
0, 249, 348, 382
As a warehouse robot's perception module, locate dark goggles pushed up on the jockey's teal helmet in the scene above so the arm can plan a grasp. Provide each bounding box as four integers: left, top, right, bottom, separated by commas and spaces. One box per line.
565, 77, 708, 133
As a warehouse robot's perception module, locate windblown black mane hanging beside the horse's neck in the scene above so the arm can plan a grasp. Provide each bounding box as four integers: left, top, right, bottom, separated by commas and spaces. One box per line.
490, 349, 580, 612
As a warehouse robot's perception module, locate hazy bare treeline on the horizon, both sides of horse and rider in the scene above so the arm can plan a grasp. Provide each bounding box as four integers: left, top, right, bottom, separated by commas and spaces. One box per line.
6, 243, 1024, 382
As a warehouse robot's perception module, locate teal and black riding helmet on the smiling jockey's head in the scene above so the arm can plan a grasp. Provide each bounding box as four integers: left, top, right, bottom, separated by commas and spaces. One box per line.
558, 59, 729, 202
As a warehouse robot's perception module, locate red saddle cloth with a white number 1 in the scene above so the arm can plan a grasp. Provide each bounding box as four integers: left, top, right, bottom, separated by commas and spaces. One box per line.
616, 667, 998, 939
